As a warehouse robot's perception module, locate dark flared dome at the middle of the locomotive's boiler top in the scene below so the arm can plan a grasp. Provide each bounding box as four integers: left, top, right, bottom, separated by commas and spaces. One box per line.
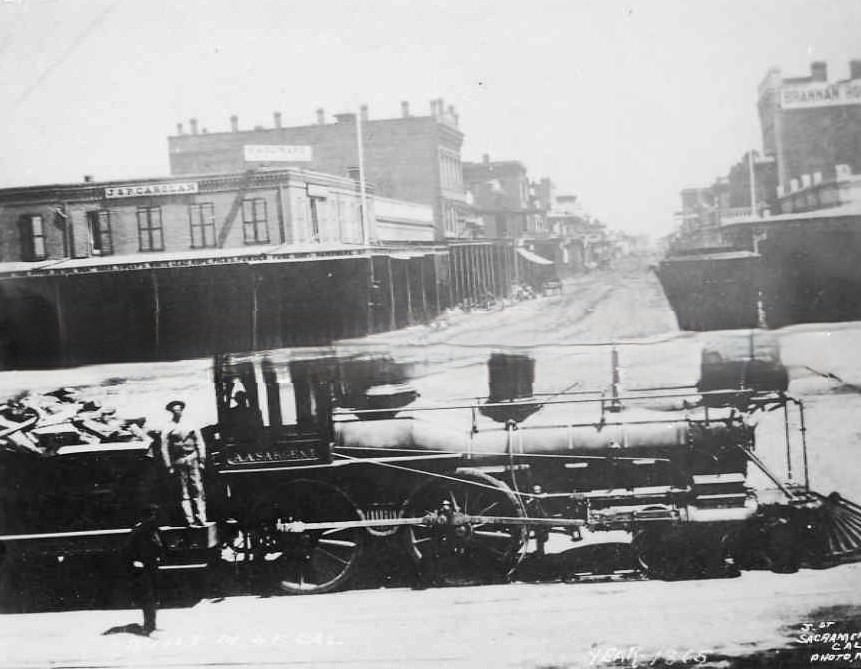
479, 353, 541, 423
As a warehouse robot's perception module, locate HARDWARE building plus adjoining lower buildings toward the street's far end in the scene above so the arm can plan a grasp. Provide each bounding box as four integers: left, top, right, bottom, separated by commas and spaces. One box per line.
168, 99, 576, 240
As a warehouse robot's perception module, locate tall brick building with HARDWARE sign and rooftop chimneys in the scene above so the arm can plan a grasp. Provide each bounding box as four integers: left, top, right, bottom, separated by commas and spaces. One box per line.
168, 99, 468, 239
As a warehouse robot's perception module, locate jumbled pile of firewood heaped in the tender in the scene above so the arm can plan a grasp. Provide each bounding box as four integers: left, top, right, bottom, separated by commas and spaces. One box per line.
0, 388, 149, 455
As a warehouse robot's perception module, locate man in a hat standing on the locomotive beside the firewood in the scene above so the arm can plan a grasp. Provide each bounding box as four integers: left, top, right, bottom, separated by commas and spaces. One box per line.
161, 400, 206, 525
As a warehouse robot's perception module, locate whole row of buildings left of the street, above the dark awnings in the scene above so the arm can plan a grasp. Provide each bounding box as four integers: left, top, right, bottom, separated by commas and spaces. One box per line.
0, 99, 597, 266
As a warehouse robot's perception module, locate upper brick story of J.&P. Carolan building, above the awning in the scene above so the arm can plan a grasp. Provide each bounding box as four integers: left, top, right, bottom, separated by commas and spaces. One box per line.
0, 168, 375, 262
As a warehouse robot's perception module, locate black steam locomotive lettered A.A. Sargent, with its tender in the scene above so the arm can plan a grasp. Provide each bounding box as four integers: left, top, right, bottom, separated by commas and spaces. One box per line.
0, 339, 861, 594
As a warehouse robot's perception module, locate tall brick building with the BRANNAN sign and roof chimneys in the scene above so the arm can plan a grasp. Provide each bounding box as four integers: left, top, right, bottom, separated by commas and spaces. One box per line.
758, 60, 861, 192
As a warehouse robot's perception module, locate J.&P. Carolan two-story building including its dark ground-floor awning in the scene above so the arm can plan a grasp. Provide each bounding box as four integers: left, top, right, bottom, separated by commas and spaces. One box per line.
0, 167, 460, 368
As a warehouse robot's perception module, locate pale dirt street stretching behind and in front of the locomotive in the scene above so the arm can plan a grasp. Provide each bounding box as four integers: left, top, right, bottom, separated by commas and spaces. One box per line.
0, 267, 861, 667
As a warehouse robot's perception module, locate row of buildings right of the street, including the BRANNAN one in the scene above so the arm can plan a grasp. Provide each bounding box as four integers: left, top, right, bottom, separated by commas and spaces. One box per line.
677, 60, 861, 246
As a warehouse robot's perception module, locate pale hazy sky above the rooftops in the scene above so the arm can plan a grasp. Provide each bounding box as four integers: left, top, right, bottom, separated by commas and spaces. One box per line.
0, 0, 861, 236
